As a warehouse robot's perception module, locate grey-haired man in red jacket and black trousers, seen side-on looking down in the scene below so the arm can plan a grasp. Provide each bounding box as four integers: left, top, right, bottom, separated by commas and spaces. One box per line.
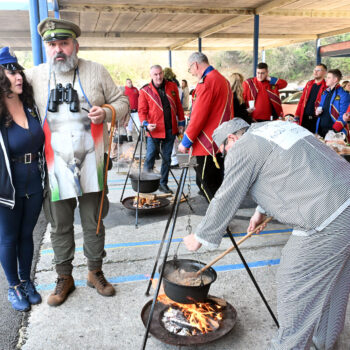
178, 52, 233, 199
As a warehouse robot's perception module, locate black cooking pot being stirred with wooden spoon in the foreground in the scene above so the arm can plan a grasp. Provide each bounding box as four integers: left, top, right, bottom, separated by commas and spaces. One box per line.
160, 259, 217, 304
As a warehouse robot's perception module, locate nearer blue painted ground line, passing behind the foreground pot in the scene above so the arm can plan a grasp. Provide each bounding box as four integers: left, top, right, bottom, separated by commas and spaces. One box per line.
36, 259, 280, 291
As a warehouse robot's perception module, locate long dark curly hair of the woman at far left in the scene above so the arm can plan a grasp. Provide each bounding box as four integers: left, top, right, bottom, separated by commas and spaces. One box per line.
0, 66, 34, 127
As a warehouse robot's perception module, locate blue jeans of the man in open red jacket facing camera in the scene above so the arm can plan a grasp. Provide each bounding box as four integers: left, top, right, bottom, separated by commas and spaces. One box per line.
143, 130, 175, 186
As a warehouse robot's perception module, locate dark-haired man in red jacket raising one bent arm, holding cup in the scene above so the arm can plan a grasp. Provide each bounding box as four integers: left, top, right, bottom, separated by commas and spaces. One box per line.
243, 63, 287, 122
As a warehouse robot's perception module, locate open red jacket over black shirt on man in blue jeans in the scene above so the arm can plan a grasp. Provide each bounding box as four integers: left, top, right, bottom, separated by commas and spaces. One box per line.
138, 80, 185, 139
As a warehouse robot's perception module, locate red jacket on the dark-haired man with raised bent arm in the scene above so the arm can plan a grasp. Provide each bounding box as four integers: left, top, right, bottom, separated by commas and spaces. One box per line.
243, 77, 288, 120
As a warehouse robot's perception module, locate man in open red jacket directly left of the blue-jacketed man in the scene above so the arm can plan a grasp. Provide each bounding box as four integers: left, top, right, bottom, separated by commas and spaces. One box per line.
295, 63, 327, 133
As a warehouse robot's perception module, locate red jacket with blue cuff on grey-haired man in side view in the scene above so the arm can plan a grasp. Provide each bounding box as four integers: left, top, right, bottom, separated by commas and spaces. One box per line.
182, 70, 233, 156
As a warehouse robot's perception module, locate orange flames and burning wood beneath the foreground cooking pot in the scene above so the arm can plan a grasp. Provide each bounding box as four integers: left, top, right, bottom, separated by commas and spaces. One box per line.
157, 294, 222, 335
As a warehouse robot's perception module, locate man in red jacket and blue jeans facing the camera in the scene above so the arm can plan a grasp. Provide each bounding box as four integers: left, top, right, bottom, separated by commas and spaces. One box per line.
138, 65, 185, 193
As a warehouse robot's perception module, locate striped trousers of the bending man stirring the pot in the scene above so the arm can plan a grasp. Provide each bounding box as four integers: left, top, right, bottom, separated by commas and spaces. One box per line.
269, 207, 350, 350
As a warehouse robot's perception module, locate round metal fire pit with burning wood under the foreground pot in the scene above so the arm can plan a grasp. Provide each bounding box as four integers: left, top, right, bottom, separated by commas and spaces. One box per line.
141, 295, 237, 346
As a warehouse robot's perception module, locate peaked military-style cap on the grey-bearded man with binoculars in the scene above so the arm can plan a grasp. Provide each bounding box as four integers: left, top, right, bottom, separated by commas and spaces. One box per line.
38, 17, 81, 42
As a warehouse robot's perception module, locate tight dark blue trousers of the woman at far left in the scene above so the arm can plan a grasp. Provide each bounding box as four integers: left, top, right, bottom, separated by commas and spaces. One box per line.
0, 191, 43, 286
